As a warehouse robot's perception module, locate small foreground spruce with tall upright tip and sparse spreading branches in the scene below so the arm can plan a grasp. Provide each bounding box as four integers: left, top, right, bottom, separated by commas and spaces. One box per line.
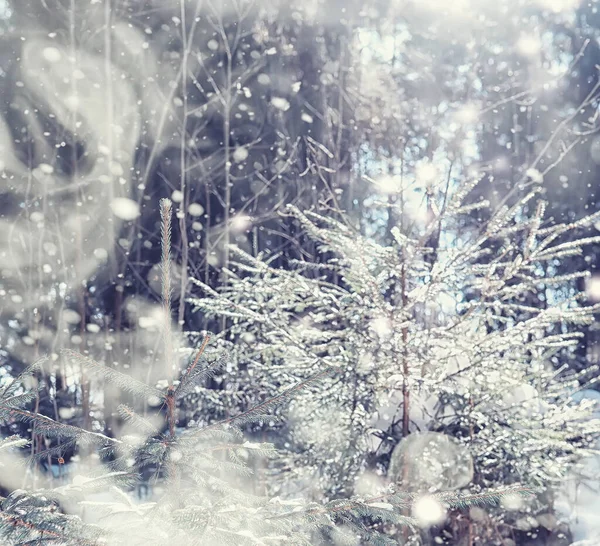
0, 201, 529, 546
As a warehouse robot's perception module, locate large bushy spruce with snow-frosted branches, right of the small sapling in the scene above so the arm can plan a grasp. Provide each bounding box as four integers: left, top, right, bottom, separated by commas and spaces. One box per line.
192, 180, 600, 544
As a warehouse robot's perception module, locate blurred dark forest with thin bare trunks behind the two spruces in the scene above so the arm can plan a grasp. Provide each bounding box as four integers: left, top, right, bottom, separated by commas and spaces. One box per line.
0, 0, 600, 544
